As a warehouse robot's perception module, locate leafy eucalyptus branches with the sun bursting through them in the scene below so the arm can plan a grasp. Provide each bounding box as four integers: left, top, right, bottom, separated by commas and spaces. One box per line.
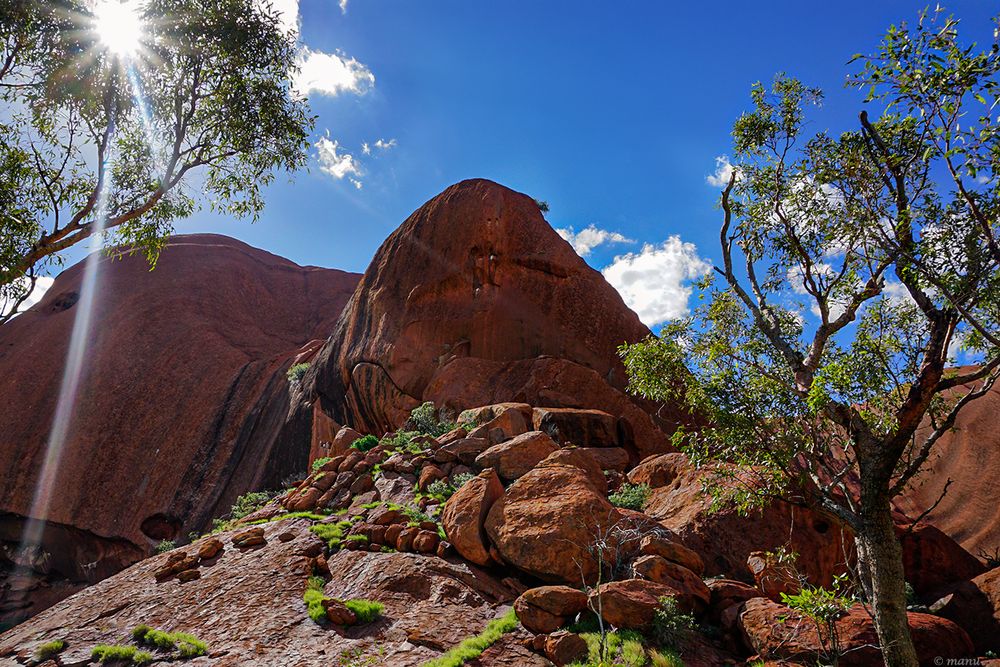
0, 0, 314, 323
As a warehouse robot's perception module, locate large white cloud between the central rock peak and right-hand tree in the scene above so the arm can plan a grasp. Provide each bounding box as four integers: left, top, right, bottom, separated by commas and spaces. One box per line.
602, 236, 712, 327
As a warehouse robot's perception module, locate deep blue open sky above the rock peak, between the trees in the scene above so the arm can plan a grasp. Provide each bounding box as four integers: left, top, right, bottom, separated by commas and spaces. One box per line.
50, 0, 995, 328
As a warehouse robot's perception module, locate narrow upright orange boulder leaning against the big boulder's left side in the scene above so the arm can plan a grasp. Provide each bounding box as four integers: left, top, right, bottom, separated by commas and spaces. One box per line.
441, 468, 504, 565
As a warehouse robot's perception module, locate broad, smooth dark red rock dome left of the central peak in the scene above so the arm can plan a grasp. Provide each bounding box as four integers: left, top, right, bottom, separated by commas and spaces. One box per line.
0, 235, 358, 620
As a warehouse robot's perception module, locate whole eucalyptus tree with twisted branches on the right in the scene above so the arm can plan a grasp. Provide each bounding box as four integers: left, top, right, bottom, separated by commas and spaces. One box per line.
622, 12, 1000, 667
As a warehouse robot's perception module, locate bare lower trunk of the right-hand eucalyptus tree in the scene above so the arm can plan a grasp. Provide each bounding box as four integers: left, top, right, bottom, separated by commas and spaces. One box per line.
855, 494, 918, 667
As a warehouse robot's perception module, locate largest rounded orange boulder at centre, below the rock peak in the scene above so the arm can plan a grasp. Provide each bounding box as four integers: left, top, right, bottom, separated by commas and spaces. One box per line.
486, 466, 620, 585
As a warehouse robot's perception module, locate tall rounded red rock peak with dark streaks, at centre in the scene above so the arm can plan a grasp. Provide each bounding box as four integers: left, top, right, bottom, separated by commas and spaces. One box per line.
314, 180, 666, 451
